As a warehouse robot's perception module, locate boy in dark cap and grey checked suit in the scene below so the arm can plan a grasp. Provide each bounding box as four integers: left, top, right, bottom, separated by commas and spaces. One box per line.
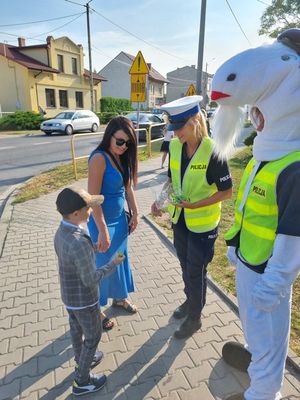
54, 187, 124, 396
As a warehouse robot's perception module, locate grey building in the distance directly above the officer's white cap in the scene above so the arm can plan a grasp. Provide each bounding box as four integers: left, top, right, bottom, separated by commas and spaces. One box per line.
167, 65, 213, 104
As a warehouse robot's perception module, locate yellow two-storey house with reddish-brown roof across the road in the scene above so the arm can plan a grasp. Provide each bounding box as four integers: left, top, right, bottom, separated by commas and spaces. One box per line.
0, 36, 106, 117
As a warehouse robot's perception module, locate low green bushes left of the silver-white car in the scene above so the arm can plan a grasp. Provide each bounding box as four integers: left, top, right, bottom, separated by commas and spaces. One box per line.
0, 111, 44, 131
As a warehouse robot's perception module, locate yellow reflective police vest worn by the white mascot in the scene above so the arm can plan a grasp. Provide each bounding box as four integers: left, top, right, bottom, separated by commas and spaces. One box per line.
224, 152, 300, 266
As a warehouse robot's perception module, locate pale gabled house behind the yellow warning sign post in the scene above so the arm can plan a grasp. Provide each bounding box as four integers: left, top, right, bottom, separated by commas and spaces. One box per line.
99, 51, 168, 109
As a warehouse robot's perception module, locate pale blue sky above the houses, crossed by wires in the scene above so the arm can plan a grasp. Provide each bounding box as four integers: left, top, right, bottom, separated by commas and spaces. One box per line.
0, 0, 271, 76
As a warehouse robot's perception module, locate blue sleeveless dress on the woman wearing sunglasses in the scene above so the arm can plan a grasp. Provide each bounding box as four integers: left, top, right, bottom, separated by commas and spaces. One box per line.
88, 150, 134, 306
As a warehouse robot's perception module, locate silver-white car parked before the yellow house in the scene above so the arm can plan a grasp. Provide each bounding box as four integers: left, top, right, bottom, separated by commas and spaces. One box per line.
40, 110, 100, 135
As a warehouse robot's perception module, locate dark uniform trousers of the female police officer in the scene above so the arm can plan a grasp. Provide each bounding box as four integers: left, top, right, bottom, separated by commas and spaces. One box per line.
173, 211, 217, 319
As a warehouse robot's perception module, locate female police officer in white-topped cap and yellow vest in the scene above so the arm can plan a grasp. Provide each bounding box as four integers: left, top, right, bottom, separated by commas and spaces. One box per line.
151, 96, 232, 338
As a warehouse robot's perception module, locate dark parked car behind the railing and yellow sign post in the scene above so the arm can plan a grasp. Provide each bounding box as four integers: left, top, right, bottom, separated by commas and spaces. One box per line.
125, 112, 166, 141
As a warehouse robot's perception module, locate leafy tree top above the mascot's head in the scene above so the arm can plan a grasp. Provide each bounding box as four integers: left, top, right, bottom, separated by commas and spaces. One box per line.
258, 0, 300, 38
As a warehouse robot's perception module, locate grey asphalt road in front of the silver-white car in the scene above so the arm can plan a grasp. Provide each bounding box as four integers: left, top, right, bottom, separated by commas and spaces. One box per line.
0, 130, 103, 195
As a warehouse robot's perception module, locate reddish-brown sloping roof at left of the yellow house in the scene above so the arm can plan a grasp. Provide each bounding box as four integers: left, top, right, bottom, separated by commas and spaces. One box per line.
0, 43, 59, 73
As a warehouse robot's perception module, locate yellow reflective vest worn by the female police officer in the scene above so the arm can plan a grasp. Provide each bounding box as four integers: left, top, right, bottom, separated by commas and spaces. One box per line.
169, 137, 221, 233
